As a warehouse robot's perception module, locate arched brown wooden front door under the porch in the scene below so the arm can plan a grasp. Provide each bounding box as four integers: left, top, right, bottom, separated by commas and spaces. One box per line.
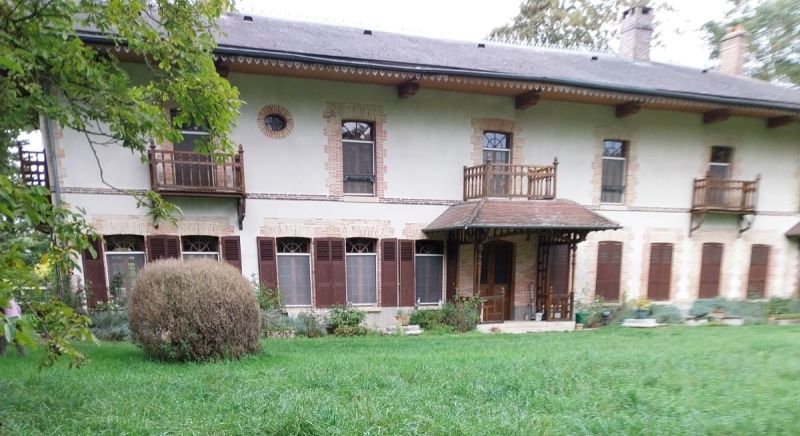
480, 241, 514, 322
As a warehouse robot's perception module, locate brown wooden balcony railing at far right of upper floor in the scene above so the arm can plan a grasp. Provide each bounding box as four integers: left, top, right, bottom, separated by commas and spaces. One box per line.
692, 177, 759, 213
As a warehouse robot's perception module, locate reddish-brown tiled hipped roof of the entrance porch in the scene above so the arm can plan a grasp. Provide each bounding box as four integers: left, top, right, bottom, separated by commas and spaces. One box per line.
423, 199, 621, 232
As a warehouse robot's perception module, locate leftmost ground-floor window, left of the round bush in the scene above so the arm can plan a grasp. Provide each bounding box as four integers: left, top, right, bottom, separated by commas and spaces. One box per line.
105, 235, 145, 301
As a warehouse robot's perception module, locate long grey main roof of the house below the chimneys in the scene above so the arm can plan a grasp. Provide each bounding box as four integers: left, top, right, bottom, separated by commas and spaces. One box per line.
212, 14, 800, 111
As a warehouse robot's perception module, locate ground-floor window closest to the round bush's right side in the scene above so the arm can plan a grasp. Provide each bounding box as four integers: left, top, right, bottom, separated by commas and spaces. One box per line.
277, 238, 311, 306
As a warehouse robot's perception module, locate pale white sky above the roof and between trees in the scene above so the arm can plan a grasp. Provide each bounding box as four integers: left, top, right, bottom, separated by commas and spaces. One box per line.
23, 0, 728, 150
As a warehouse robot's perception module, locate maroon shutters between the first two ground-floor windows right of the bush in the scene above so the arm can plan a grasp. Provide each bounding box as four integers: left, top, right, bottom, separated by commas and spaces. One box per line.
314, 238, 347, 307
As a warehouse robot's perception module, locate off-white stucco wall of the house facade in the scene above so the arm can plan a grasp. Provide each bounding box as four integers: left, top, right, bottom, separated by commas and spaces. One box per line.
59, 68, 800, 308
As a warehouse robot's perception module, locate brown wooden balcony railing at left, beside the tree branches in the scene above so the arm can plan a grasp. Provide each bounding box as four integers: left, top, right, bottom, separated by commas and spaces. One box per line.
147, 146, 245, 197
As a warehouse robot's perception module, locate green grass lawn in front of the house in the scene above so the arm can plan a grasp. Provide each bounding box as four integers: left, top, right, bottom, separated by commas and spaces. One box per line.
0, 326, 800, 435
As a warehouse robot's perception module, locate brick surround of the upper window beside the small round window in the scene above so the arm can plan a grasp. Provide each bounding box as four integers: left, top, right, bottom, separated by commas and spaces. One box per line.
322, 102, 386, 198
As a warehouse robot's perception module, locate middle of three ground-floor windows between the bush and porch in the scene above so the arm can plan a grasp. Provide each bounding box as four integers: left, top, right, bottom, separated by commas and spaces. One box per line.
345, 238, 378, 304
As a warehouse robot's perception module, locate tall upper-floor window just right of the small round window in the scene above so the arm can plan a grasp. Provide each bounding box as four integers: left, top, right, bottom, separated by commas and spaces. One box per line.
342, 121, 375, 195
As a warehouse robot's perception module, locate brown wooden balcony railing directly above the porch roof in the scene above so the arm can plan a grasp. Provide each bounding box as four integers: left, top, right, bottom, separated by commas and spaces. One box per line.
464, 159, 558, 200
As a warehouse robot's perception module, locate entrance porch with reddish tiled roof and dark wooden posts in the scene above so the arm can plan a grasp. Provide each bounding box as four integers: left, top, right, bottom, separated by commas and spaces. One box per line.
423, 198, 620, 322
